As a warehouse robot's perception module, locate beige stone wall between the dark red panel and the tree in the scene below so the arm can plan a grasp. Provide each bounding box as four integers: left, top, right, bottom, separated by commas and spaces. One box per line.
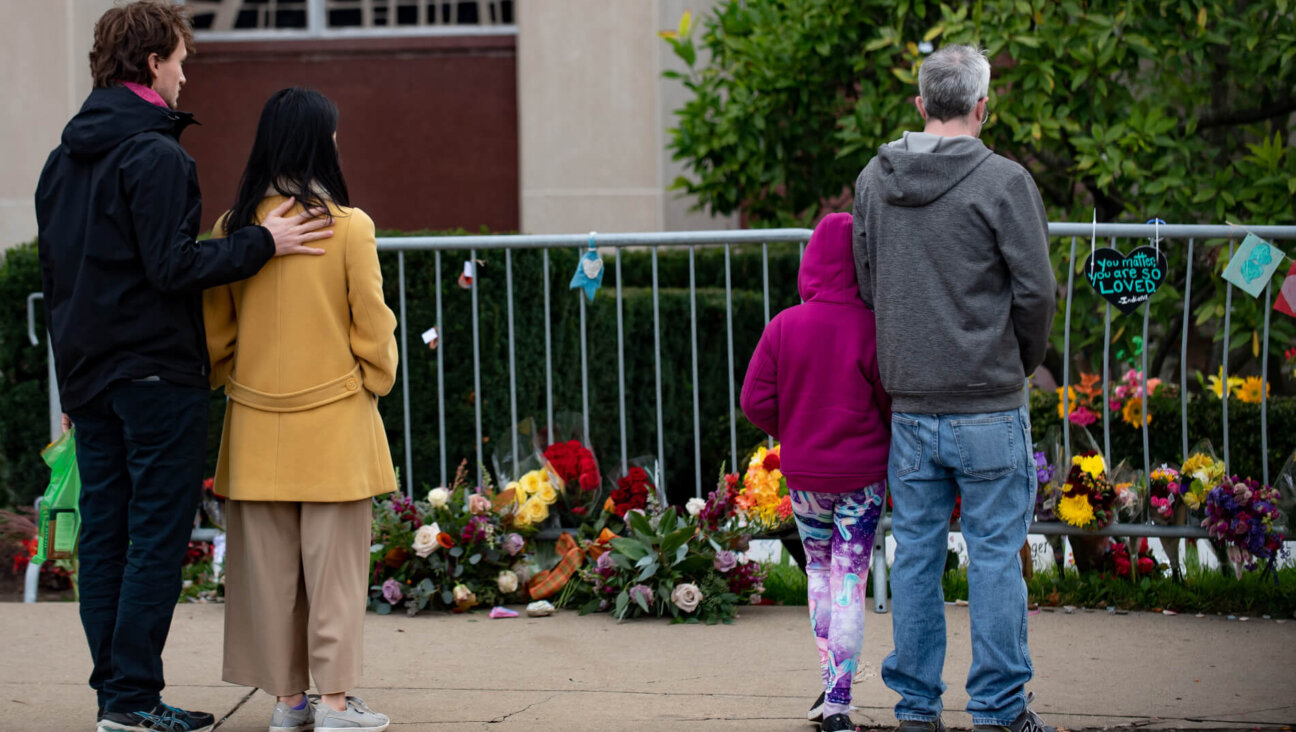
517, 0, 736, 233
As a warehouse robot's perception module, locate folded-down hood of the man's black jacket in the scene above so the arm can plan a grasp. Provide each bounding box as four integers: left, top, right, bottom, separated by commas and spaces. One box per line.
62, 87, 193, 159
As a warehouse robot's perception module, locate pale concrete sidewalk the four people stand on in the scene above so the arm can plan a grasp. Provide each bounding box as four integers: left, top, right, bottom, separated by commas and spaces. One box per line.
0, 602, 1296, 732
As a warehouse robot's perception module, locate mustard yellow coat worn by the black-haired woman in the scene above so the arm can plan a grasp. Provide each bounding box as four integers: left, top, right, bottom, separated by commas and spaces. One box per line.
203, 196, 398, 503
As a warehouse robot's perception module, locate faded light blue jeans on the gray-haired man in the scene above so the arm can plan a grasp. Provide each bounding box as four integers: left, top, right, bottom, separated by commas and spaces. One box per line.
881, 407, 1036, 726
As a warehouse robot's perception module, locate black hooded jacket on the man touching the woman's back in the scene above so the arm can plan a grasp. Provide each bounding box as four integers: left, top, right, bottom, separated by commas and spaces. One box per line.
36, 87, 275, 411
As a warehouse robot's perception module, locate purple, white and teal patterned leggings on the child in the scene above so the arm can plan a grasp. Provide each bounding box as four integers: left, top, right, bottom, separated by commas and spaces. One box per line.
792, 482, 886, 705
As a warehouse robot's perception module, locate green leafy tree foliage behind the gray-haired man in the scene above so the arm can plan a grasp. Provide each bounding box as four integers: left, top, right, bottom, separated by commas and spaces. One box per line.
666, 0, 1296, 383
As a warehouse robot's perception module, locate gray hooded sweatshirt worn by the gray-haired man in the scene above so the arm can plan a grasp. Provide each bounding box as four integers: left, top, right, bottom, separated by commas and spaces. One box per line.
853, 132, 1056, 415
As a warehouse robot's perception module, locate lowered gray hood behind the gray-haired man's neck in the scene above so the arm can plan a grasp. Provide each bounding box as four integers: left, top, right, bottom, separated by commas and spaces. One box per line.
877, 132, 991, 207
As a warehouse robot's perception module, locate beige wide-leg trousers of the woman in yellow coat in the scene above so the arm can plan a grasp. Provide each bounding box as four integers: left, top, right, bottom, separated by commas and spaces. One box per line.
222, 499, 373, 696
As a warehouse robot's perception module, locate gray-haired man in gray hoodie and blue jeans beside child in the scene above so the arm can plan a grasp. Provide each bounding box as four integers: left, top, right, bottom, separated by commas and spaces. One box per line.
854, 45, 1056, 732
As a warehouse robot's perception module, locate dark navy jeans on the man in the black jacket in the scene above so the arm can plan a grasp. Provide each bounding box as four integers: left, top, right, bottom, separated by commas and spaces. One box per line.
70, 381, 207, 713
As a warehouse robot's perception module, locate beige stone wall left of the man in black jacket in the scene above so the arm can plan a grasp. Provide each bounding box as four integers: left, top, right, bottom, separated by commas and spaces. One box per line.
0, 0, 111, 249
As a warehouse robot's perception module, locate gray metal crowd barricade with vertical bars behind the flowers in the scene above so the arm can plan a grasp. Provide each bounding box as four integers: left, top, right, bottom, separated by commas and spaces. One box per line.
17, 223, 1296, 613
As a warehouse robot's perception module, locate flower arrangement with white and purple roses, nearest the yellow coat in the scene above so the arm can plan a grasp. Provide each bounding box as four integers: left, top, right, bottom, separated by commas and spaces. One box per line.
369, 460, 531, 615
